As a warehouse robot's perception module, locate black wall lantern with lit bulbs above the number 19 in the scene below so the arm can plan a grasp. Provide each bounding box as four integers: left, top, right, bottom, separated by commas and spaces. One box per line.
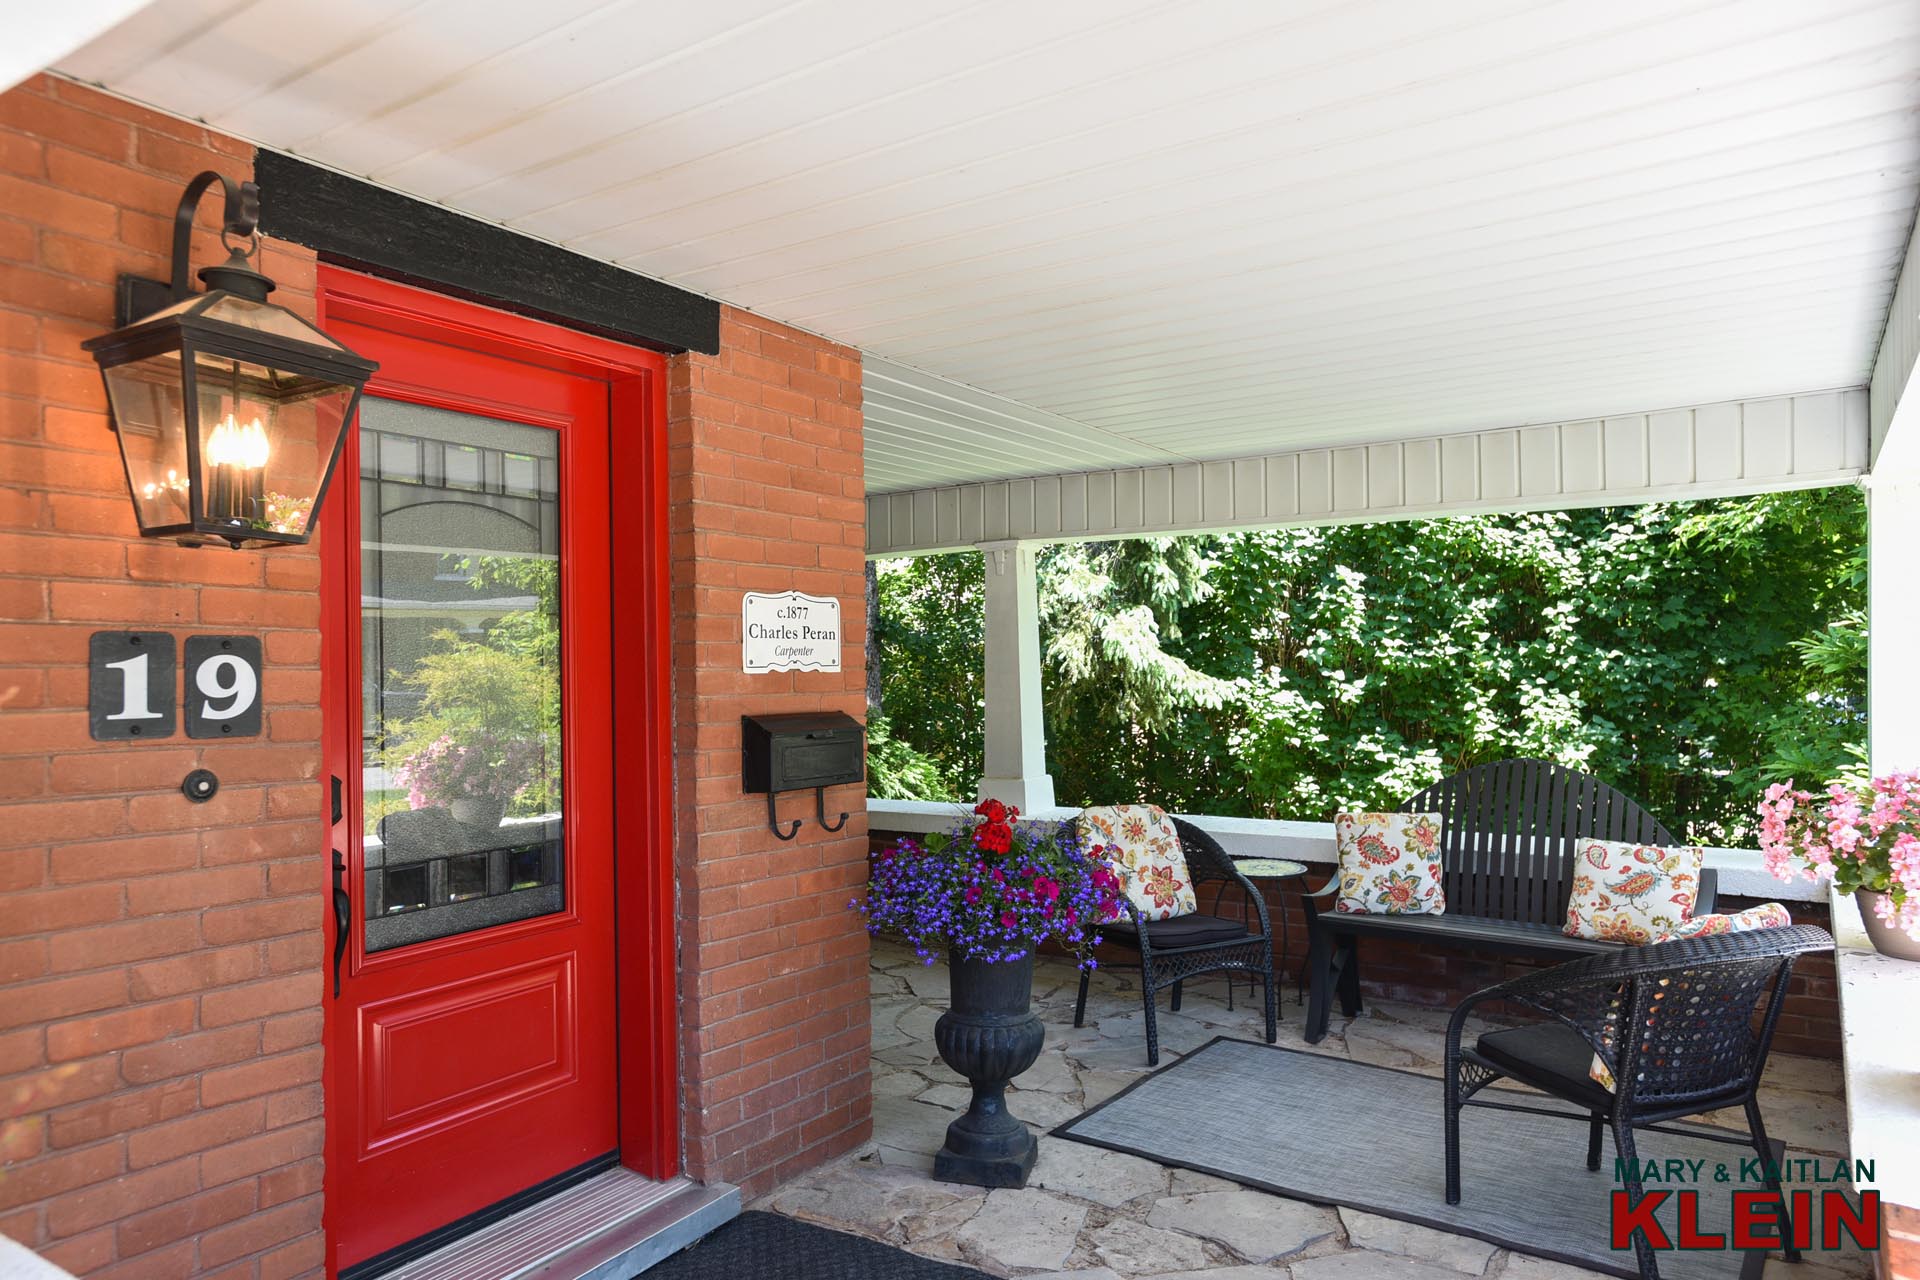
83, 169, 378, 547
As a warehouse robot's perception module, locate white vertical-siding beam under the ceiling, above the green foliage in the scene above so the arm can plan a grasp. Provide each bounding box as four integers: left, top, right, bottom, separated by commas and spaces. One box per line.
866, 388, 1868, 557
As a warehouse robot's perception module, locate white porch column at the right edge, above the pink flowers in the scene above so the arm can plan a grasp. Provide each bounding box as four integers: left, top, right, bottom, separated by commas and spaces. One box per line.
1866, 470, 1920, 773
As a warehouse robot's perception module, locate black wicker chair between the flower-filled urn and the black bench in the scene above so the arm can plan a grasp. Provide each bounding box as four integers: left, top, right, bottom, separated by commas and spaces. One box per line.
1073, 818, 1279, 1067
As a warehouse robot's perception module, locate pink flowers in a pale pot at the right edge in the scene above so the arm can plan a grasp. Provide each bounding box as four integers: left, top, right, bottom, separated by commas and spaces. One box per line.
1759, 773, 1920, 960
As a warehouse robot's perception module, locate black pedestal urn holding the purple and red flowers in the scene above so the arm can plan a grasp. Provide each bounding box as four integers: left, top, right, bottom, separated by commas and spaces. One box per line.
933, 952, 1046, 1186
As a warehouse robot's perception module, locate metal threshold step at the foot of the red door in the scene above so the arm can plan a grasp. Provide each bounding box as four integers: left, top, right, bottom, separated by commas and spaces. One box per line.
380, 1169, 739, 1280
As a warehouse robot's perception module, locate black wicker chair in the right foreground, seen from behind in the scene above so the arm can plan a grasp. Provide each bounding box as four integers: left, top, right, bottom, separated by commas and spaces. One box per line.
1446, 925, 1834, 1280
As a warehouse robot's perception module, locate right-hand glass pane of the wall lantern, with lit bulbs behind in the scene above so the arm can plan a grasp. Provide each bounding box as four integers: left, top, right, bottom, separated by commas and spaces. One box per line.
194, 347, 353, 537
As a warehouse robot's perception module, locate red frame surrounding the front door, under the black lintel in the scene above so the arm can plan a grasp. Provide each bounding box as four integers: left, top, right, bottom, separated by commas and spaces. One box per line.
315, 263, 680, 1257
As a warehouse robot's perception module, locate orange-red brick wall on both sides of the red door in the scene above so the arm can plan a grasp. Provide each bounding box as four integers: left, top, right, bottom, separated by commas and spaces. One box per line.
0, 77, 868, 1280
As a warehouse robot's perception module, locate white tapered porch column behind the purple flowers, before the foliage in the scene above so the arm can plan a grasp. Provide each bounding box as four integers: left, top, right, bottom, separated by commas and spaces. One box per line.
979, 541, 1054, 812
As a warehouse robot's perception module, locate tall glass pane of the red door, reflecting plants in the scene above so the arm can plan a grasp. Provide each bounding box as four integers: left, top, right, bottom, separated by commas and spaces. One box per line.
361, 397, 564, 952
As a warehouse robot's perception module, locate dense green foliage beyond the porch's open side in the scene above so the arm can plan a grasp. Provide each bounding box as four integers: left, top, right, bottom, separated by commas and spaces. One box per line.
879, 489, 1866, 842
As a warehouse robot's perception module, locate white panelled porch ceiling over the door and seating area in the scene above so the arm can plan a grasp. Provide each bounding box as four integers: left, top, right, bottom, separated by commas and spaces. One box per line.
61, 0, 1920, 491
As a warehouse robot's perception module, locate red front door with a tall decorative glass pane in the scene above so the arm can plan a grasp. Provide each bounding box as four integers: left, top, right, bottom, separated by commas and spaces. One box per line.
321, 278, 618, 1272
